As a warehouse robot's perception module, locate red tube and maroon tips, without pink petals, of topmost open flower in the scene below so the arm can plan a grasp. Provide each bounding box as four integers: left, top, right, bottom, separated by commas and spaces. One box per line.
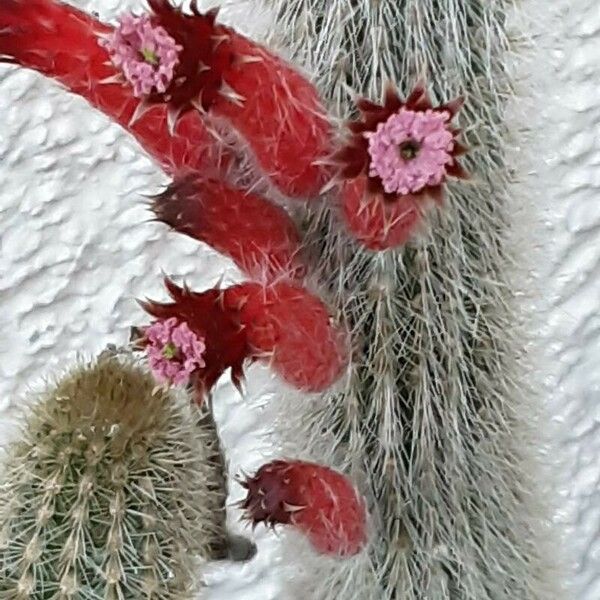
138, 0, 332, 199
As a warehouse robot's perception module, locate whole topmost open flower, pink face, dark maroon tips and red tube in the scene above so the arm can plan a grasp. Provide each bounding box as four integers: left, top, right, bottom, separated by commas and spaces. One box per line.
101, 0, 333, 200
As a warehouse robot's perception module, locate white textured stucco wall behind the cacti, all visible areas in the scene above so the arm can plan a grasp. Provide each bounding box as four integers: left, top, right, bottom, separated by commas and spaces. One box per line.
0, 0, 600, 600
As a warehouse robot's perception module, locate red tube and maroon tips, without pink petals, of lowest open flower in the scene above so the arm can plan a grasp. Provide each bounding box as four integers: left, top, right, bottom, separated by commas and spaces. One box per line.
141, 279, 347, 392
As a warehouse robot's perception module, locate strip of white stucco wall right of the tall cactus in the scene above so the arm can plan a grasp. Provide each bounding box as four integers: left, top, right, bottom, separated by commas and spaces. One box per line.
538, 0, 600, 600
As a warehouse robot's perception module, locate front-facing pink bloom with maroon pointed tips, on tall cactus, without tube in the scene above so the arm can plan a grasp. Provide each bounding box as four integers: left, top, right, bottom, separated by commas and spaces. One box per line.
336, 85, 467, 202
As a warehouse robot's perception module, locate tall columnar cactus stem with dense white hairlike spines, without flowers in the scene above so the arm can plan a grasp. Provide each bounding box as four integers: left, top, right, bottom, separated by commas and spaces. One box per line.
263, 0, 558, 600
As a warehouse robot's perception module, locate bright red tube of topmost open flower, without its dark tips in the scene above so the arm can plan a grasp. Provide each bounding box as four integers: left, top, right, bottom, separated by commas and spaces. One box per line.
211, 29, 335, 200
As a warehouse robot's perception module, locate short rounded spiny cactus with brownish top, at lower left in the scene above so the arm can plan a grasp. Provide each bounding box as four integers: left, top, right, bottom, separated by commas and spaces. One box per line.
0, 356, 225, 600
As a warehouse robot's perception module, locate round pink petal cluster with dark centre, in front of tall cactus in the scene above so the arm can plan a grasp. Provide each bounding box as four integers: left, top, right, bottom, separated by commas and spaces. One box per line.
364, 108, 454, 195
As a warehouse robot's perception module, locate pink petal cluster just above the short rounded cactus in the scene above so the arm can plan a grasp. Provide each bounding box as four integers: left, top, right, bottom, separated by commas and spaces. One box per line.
145, 317, 206, 385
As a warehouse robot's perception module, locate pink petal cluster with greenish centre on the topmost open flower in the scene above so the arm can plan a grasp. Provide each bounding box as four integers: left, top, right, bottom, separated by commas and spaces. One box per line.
102, 14, 183, 98
